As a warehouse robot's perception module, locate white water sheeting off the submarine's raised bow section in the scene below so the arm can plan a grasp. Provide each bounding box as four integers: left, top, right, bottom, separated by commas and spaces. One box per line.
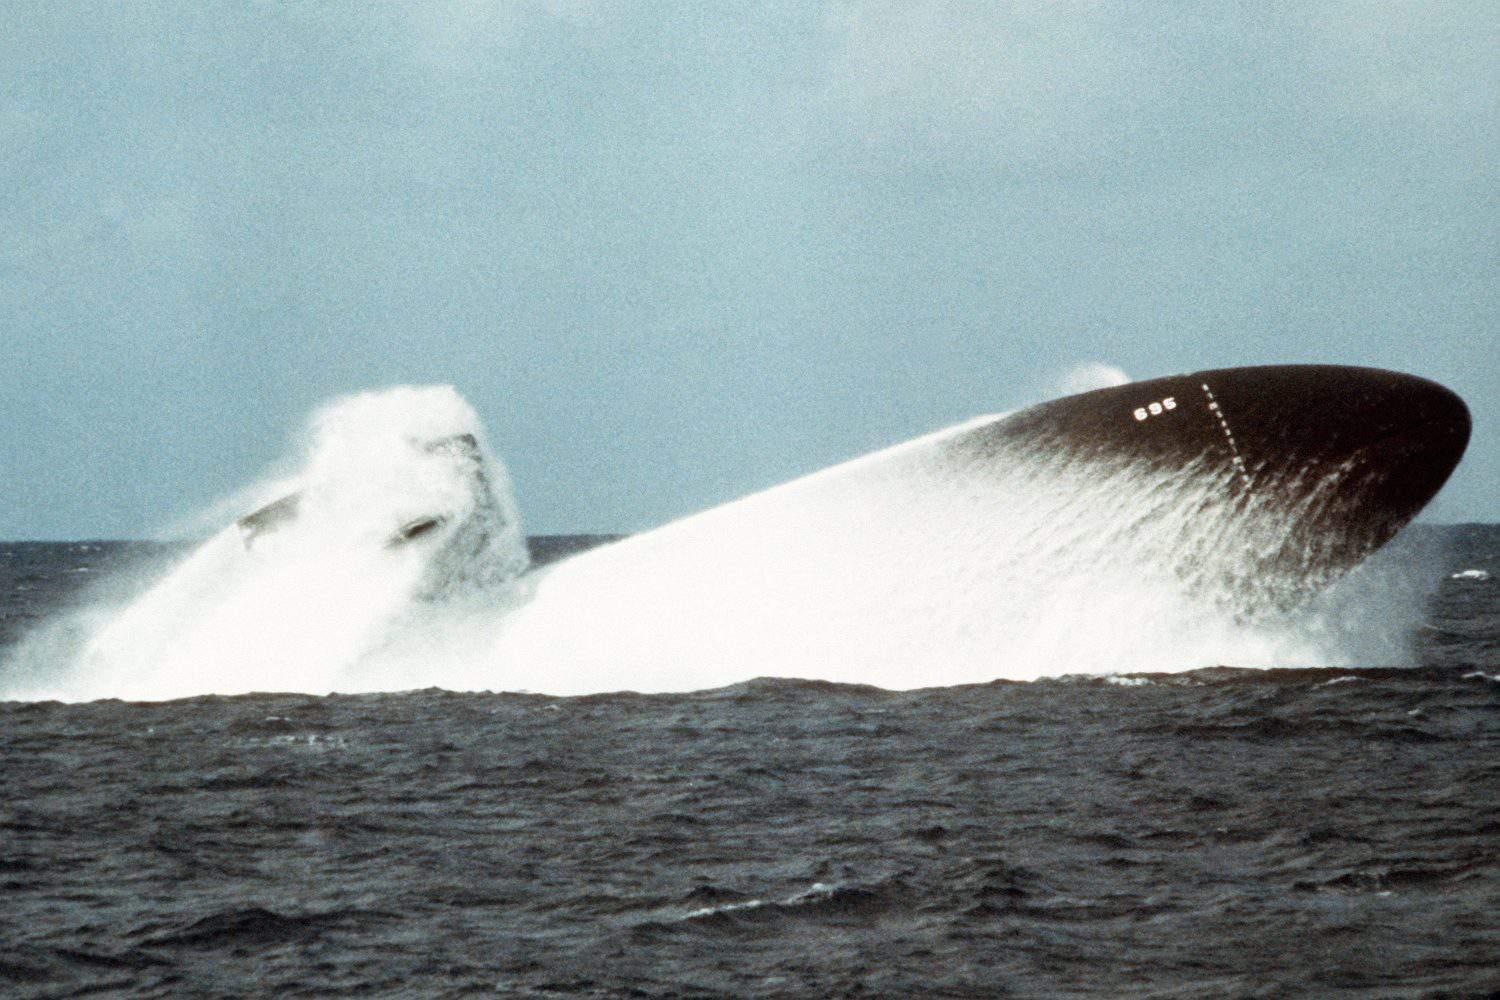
486, 418, 1418, 694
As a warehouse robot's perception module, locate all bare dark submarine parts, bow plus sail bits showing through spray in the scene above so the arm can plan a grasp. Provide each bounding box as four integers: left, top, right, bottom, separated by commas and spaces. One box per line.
237, 364, 1472, 582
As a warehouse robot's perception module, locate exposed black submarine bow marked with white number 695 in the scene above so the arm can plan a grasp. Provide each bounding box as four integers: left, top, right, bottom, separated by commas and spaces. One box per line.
950, 364, 1470, 604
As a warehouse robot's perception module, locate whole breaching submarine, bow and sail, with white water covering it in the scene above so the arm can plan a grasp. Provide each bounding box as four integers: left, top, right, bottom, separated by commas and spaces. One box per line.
67, 364, 1470, 697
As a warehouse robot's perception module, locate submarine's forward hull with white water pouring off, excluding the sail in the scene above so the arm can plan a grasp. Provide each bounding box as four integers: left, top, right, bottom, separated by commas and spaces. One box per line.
497, 366, 1469, 694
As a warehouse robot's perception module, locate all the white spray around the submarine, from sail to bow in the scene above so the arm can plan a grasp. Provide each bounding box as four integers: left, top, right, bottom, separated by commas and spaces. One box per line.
0, 388, 1431, 700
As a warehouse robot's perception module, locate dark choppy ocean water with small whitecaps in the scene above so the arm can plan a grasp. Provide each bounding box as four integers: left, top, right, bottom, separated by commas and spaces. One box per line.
0, 526, 1500, 997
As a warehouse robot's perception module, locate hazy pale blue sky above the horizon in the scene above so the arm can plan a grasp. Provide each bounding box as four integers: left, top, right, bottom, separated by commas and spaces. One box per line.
0, 0, 1500, 538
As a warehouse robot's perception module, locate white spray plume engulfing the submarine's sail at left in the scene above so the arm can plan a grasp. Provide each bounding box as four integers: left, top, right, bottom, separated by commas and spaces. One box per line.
3, 387, 527, 700
